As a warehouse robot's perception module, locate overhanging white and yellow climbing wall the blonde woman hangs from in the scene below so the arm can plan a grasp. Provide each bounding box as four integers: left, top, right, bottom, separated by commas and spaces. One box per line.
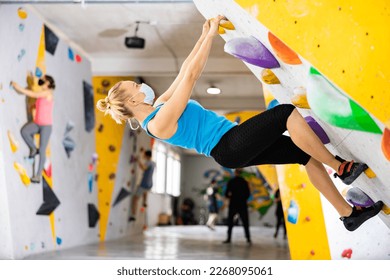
194, 0, 390, 259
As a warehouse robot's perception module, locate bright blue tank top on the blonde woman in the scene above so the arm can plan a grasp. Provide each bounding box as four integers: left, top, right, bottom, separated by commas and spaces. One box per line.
141, 100, 237, 157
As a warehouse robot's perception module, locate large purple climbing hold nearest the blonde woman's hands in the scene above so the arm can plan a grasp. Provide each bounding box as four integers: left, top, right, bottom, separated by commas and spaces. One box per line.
224, 36, 280, 69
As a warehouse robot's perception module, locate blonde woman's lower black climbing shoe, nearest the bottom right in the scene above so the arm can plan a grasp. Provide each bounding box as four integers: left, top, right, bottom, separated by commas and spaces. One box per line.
340, 201, 383, 231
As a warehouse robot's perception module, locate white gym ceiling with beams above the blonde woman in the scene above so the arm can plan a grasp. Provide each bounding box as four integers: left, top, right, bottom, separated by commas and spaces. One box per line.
23, 0, 264, 113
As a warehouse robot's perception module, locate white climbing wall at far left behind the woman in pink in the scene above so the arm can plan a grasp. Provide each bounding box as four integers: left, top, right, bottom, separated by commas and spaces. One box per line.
0, 5, 95, 258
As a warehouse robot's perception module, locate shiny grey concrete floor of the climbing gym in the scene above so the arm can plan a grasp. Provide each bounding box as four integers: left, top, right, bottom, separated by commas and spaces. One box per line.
27, 226, 290, 260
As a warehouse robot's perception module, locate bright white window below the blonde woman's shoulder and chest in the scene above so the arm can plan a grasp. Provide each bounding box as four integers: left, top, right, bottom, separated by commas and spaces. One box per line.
152, 141, 181, 196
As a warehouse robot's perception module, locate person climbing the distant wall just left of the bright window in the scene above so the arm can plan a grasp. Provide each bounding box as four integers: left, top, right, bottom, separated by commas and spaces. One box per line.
129, 150, 156, 222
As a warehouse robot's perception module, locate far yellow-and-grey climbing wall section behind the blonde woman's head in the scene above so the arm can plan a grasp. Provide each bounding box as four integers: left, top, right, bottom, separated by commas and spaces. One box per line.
93, 76, 150, 241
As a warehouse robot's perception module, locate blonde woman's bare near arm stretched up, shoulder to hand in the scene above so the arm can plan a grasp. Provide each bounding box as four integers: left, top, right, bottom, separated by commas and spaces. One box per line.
148, 16, 224, 139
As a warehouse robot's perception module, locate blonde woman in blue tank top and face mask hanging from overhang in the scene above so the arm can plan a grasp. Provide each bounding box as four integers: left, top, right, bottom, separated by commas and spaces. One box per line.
97, 16, 383, 231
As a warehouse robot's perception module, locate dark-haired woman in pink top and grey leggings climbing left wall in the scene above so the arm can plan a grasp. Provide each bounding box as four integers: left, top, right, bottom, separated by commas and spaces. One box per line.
11, 75, 55, 183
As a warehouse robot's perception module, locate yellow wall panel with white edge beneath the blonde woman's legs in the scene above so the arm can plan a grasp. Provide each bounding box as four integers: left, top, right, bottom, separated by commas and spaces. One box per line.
277, 164, 331, 260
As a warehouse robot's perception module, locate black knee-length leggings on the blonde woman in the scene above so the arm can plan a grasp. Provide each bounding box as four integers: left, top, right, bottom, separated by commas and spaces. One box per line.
211, 104, 310, 168
